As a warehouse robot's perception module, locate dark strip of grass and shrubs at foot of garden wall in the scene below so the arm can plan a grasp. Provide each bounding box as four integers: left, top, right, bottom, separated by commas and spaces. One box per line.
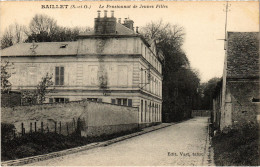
1, 129, 138, 161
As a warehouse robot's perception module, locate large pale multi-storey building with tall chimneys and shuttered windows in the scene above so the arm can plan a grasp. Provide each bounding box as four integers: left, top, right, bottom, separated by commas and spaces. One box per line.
1, 11, 164, 124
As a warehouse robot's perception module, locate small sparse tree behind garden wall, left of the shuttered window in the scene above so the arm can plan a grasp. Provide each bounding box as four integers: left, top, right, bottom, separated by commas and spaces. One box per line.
22, 73, 53, 104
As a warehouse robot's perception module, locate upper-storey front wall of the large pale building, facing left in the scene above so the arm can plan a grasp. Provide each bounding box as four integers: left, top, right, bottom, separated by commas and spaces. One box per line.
3, 55, 134, 89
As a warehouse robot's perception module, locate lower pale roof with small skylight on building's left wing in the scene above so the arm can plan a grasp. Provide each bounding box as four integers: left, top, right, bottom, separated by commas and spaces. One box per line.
0, 42, 78, 56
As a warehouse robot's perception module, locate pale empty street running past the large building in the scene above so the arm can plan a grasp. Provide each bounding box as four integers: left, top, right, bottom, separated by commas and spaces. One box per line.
27, 117, 213, 166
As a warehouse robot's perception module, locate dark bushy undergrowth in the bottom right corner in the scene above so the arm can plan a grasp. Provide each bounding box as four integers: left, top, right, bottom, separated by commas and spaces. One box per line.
212, 123, 260, 166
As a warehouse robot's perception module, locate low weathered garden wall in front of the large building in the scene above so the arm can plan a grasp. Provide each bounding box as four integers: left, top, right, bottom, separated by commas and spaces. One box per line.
1, 101, 138, 136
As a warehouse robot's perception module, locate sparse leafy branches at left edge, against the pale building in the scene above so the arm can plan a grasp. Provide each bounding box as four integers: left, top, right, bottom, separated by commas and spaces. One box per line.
1, 61, 13, 93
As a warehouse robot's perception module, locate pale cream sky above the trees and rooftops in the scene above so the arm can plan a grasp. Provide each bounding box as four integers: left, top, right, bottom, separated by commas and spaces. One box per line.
0, 1, 259, 82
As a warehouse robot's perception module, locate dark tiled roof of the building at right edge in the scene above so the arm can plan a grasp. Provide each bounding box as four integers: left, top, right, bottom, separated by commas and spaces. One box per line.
226, 32, 259, 78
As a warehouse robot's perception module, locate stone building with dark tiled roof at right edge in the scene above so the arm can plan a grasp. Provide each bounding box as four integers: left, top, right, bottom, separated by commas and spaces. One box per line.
213, 32, 260, 130
